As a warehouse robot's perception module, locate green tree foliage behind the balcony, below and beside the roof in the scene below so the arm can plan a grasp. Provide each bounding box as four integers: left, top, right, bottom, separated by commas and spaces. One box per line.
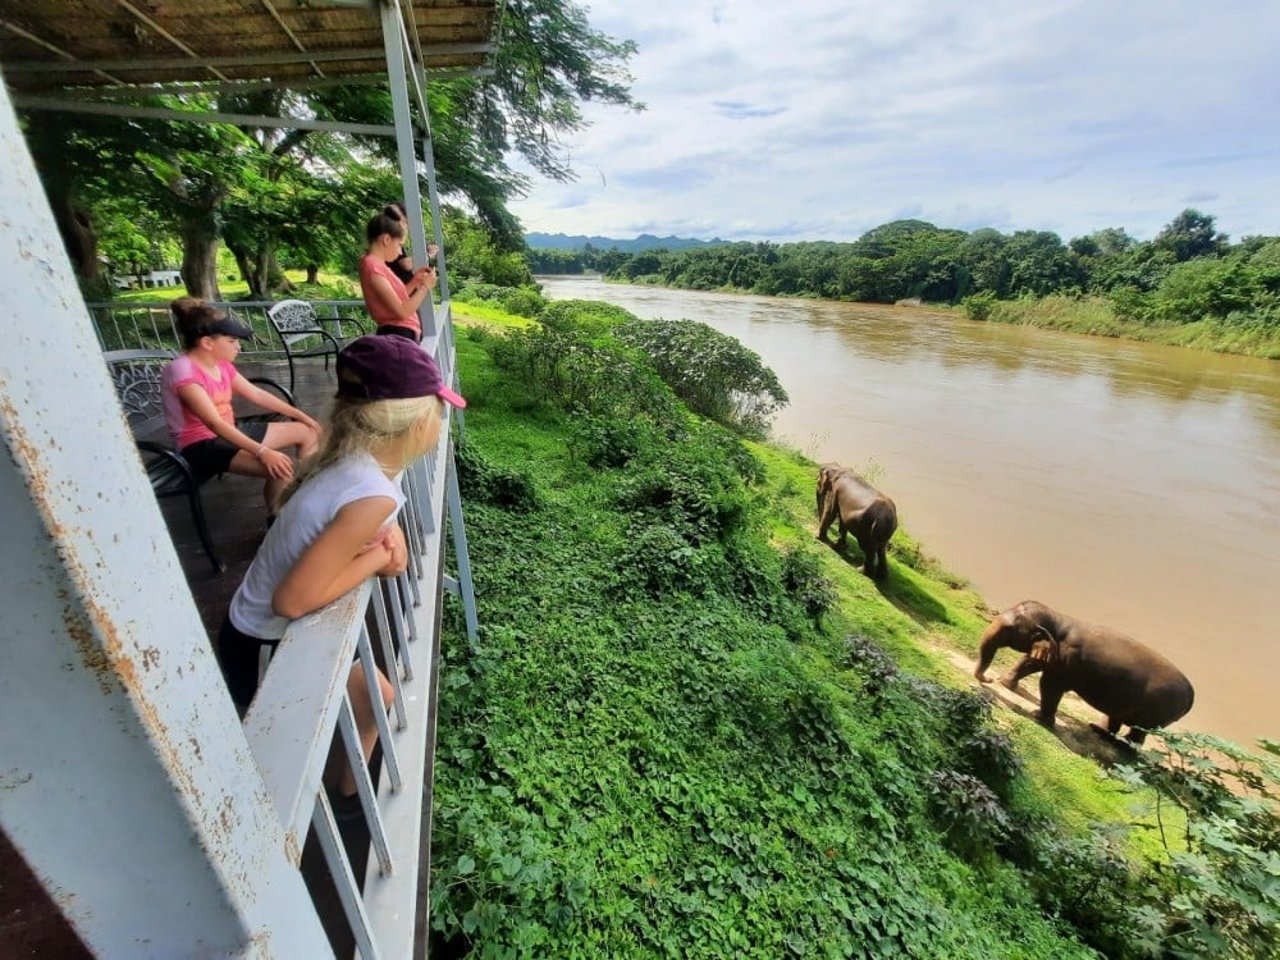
20, 0, 640, 297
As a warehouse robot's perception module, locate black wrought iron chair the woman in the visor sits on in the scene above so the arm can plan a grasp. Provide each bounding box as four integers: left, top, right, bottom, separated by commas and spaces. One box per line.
102, 349, 294, 573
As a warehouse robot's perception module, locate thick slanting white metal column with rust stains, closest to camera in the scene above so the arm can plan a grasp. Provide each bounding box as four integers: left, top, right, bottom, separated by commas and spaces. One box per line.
0, 86, 330, 957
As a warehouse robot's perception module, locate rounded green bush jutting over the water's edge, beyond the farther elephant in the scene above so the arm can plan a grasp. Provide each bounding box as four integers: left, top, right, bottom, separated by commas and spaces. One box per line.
616, 320, 787, 435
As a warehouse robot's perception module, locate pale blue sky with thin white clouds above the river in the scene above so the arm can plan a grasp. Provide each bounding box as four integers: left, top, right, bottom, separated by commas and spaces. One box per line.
512, 0, 1280, 242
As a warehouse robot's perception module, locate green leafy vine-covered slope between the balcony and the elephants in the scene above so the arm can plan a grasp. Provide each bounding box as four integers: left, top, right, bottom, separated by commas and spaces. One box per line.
431, 302, 1280, 957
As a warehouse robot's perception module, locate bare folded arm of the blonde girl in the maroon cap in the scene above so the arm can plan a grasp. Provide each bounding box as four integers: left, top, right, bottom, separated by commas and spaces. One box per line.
271, 497, 396, 620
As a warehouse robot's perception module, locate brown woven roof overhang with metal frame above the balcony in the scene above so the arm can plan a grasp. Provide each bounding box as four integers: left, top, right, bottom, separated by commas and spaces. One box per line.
0, 0, 499, 96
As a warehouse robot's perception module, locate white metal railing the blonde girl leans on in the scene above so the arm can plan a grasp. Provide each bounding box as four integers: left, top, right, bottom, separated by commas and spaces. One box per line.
244, 325, 475, 960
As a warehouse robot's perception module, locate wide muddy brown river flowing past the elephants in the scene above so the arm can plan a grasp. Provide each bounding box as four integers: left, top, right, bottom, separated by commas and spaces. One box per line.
540, 278, 1280, 742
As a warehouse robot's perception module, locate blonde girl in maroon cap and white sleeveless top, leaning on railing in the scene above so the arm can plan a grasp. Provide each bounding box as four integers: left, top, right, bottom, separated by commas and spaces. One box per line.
218, 337, 466, 796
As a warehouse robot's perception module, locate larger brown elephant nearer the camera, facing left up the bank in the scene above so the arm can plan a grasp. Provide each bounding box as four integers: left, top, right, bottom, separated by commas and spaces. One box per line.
973, 600, 1196, 744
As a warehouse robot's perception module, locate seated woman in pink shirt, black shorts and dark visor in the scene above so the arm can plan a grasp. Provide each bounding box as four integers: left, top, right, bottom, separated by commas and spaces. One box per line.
161, 297, 320, 516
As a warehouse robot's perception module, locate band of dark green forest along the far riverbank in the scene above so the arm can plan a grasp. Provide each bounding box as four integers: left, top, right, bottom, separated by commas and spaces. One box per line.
529, 210, 1280, 334
